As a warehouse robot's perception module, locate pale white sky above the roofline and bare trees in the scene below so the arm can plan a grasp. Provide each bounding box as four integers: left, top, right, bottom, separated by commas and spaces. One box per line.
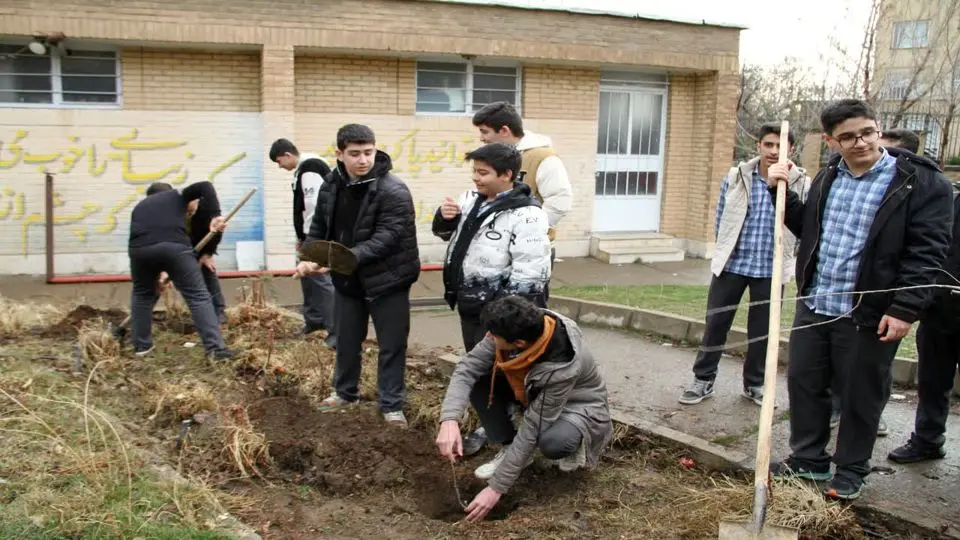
442, 0, 871, 77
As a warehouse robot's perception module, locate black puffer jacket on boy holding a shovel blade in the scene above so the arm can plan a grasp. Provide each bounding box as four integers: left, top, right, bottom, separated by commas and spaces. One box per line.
307, 150, 420, 298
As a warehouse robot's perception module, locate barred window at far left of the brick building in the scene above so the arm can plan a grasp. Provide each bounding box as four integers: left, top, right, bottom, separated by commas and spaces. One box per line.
0, 44, 119, 106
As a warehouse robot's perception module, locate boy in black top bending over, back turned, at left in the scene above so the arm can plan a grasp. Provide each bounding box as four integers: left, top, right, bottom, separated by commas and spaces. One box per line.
128, 182, 234, 360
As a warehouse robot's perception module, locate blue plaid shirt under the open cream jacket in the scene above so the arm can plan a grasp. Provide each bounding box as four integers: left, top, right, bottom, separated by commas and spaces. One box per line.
715, 168, 775, 278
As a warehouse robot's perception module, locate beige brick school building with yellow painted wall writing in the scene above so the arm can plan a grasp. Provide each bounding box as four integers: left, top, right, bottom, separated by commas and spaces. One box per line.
0, 0, 740, 275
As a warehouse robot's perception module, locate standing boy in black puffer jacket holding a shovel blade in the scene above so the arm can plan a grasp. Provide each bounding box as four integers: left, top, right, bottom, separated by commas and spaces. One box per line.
297, 124, 420, 426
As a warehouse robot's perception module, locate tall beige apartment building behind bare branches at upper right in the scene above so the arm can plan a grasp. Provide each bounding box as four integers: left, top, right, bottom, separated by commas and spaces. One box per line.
871, 0, 960, 164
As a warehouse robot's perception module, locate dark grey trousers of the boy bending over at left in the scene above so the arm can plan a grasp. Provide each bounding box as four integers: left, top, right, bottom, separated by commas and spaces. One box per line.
130, 242, 226, 352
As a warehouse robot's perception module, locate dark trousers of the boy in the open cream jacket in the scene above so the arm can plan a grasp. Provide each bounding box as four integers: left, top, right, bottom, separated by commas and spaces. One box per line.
693, 272, 771, 388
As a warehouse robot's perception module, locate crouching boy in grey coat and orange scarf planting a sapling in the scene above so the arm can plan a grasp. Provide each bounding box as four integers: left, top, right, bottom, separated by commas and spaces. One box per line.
437, 296, 613, 521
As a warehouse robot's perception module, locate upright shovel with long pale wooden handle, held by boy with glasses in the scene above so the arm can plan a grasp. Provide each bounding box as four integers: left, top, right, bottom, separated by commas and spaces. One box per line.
720, 120, 799, 540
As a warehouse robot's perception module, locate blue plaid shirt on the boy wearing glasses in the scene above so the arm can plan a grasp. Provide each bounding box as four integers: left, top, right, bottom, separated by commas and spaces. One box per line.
804, 148, 897, 317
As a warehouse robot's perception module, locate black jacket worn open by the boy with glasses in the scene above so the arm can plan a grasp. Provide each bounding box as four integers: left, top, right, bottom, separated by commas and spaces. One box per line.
771, 148, 953, 327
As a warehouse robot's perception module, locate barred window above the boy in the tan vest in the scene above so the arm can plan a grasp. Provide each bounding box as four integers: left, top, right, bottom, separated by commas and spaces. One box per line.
417, 62, 520, 114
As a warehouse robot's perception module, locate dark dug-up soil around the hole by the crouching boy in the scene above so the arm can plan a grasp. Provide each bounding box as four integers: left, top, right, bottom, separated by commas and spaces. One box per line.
248, 397, 580, 522
